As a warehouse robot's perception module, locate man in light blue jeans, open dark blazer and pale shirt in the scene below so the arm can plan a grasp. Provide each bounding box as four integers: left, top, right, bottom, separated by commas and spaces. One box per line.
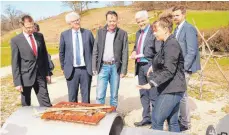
92, 11, 128, 107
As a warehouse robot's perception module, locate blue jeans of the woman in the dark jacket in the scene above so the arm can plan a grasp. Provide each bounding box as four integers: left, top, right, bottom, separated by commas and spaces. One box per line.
152, 92, 184, 132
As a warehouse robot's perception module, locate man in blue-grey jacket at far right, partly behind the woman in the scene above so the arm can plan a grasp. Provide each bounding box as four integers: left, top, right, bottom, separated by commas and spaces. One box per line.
172, 6, 201, 131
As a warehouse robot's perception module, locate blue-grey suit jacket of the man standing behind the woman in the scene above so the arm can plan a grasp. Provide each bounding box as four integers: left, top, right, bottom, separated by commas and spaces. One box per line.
177, 21, 201, 73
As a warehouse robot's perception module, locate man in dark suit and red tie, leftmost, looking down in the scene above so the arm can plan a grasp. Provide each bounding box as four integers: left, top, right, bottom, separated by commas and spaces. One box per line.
11, 15, 52, 107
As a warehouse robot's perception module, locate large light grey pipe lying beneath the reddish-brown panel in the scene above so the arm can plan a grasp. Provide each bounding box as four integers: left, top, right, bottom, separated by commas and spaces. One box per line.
1, 107, 124, 135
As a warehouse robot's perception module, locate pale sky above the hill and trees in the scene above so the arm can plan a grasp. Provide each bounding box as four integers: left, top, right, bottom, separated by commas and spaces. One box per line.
1, 1, 130, 20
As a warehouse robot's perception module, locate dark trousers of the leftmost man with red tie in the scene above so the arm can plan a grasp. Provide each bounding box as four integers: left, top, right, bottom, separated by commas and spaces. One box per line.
21, 72, 52, 107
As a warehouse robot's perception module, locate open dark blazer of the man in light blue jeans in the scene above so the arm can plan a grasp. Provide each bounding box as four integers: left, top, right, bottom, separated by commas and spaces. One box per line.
92, 26, 128, 74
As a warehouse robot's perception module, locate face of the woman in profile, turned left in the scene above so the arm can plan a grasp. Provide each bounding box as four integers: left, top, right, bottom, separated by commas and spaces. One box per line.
153, 23, 167, 41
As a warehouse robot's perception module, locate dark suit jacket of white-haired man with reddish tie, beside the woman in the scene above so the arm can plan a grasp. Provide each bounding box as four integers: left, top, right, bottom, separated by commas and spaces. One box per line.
133, 27, 161, 75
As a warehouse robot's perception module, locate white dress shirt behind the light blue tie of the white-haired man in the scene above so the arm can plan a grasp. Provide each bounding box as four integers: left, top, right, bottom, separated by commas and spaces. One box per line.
72, 29, 85, 67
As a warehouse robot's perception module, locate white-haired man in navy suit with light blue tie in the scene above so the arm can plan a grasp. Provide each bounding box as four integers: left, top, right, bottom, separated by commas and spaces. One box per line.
59, 12, 94, 103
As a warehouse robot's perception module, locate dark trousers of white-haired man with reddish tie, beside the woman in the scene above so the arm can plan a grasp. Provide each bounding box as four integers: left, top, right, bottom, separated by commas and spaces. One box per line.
137, 63, 158, 122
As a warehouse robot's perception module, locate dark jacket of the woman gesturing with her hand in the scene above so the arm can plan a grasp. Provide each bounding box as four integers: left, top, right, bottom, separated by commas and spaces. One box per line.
149, 35, 187, 94
